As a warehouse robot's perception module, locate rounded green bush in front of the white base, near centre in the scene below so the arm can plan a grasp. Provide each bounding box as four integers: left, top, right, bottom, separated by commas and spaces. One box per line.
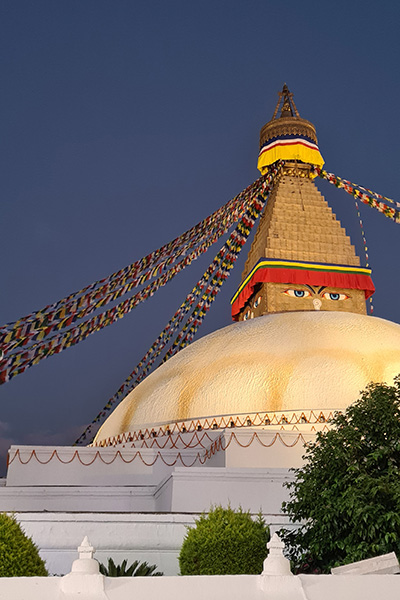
179, 506, 269, 575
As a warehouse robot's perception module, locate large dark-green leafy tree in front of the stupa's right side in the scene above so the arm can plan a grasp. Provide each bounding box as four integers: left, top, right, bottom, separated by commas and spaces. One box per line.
281, 377, 400, 572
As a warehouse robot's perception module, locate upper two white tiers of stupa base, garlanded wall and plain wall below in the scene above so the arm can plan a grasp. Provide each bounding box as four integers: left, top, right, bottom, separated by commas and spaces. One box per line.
0, 428, 308, 514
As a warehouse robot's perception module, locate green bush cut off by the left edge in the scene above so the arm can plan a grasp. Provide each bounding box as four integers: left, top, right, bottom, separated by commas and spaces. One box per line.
0, 513, 48, 577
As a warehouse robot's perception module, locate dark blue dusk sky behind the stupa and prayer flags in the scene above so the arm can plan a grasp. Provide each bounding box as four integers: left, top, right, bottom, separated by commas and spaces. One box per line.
0, 0, 400, 468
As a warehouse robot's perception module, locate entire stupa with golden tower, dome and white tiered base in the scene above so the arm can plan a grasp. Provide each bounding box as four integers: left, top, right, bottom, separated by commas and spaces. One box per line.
0, 86, 400, 574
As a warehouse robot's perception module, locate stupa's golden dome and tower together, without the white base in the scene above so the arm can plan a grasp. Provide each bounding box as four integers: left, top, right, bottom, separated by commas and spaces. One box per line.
95, 86, 392, 445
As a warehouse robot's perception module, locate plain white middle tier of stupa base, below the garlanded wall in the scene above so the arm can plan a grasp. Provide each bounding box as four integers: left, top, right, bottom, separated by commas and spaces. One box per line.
0, 454, 296, 513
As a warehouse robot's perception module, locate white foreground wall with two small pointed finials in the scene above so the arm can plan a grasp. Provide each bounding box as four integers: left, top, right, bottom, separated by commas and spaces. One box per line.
0, 536, 400, 600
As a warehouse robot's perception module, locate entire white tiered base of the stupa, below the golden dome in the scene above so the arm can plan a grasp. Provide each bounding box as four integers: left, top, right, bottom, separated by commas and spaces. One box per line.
0, 427, 315, 575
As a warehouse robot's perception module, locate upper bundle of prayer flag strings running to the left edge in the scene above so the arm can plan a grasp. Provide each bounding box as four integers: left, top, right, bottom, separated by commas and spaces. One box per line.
0, 170, 276, 384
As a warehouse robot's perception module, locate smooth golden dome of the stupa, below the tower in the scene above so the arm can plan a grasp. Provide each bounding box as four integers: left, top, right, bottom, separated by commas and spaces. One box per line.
95, 311, 400, 443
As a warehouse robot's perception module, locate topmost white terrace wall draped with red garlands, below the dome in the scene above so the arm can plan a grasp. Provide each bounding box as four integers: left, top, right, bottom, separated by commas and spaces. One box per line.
5, 426, 306, 490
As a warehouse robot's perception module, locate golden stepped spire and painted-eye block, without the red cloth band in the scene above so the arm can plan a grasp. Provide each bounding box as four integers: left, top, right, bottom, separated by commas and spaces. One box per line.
239, 163, 366, 320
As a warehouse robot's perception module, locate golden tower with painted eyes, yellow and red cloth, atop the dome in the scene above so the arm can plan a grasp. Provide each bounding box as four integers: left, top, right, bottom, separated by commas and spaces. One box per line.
232, 85, 374, 321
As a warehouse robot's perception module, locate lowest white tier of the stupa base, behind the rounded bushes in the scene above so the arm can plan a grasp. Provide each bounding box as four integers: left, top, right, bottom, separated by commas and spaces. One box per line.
16, 512, 288, 575
